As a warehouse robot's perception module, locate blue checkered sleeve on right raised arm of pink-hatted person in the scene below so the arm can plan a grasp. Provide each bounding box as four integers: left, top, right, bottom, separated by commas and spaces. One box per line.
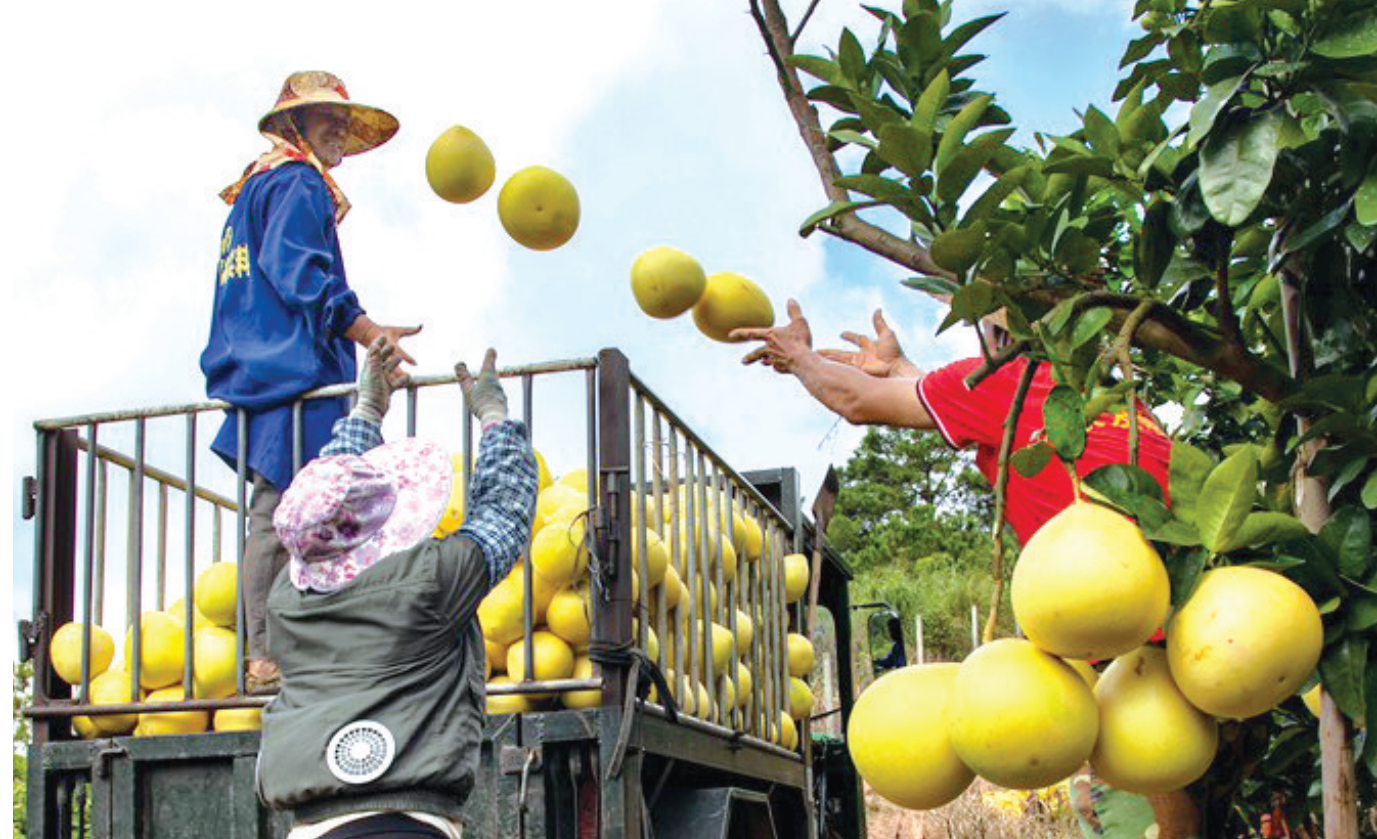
459, 420, 540, 586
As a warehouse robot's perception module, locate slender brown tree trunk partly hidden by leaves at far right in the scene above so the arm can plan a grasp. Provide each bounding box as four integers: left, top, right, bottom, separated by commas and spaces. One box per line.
1282, 269, 1358, 839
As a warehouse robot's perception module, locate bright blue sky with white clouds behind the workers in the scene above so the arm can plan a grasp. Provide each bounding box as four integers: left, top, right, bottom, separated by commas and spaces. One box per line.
0, 0, 1140, 666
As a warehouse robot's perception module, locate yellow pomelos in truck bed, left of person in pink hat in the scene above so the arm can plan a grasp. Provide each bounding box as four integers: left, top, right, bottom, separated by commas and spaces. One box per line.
48, 562, 259, 738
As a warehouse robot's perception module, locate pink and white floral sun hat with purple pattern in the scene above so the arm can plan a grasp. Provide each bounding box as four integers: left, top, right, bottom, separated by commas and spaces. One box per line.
273, 438, 454, 591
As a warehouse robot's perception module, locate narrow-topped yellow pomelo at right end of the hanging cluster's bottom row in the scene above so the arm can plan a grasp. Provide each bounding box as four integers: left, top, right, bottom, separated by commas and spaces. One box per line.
1091, 646, 1219, 795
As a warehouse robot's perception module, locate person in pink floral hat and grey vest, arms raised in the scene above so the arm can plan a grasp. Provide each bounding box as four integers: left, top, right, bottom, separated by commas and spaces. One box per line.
257, 334, 538, 839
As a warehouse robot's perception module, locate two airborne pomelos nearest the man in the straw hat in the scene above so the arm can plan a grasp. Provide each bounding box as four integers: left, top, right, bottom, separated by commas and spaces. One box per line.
425, 125, 580, 251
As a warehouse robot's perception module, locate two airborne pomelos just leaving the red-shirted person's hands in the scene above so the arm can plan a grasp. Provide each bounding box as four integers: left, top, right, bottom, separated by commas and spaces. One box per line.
631, 245, 774, 343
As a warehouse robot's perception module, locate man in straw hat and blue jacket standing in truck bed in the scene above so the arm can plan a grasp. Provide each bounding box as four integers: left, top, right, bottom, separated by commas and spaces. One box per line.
201, 72, 420, 693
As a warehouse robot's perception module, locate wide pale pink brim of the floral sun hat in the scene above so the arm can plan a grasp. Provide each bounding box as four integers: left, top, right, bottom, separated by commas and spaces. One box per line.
364, 437, 454, 558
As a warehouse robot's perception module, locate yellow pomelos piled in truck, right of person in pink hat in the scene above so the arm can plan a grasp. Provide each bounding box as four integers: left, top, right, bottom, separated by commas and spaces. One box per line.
459, 456, 814, 748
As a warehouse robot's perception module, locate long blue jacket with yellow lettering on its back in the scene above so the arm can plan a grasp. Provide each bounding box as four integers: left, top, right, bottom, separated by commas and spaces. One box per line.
201, 163, 364, 489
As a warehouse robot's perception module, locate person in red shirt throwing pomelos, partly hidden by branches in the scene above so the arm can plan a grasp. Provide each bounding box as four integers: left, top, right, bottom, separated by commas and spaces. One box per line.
731, 300, 1170, 544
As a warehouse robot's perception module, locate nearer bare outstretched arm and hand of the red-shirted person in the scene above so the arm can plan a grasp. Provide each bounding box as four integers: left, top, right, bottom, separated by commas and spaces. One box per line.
731, 300, 935, 428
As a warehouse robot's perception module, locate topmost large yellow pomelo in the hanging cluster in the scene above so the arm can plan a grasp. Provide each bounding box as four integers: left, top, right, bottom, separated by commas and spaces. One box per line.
1011, 503, 1172, 660
